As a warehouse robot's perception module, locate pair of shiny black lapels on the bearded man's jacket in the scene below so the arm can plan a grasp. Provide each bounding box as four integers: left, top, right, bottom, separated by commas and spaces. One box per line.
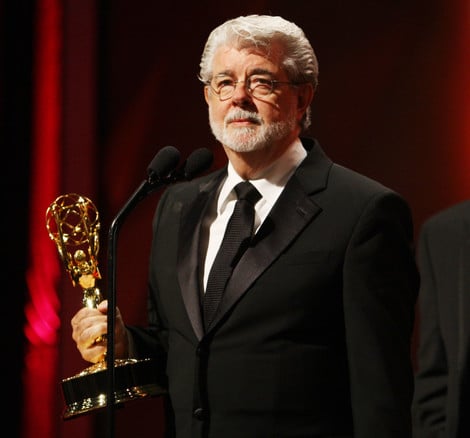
178, 141, 332, 339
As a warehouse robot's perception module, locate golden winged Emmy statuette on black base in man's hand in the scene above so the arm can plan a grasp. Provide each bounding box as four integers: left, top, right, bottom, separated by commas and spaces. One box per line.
46, 193, 166, 420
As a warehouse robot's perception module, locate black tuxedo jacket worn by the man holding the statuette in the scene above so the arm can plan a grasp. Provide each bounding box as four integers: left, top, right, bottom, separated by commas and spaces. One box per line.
129, 140, 418, 438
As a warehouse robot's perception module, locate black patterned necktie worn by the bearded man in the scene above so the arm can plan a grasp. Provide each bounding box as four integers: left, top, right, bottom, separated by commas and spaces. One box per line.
203, 181, 261, 329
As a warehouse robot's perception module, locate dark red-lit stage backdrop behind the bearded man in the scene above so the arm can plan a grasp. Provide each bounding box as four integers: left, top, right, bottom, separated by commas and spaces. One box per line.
18, 0, 470, 438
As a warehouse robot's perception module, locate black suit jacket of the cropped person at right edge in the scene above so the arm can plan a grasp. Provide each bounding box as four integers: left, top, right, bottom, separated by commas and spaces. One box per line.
413, 201, 470, 438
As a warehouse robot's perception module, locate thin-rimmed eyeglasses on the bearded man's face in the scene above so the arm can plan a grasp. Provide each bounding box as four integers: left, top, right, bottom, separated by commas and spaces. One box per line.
205, 76, 298, 101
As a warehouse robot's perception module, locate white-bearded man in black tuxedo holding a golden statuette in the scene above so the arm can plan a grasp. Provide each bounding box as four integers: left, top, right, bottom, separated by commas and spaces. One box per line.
72, 16, 418, 438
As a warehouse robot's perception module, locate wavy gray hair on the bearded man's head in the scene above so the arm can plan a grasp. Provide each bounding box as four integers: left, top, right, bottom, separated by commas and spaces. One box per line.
199, 15, 318, 129
